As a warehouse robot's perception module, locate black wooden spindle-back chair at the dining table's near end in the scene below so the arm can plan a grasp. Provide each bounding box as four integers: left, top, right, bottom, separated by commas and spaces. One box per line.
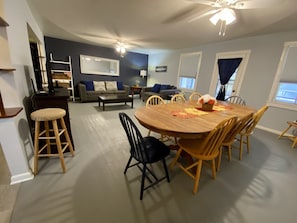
119, 112, 170, 200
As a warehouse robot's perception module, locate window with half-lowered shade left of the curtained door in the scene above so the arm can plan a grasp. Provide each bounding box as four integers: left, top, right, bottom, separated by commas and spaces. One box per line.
177, 52, 201, 91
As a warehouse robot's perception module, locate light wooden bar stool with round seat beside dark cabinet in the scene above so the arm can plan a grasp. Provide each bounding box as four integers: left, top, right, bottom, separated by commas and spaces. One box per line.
30, 108, 74, 175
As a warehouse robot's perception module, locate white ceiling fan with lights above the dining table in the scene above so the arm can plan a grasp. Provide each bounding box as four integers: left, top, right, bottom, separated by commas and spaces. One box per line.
188, 0, 282, 36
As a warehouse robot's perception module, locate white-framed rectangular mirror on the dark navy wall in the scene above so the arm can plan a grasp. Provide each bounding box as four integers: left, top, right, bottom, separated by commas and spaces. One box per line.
80, 55, 120, 76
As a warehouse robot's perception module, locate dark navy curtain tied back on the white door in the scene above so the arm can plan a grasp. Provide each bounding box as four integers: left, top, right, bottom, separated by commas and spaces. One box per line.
217, 58, 242, 101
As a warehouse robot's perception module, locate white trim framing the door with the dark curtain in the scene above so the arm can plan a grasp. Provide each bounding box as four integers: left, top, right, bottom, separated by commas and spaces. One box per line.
209, 50, 251, 94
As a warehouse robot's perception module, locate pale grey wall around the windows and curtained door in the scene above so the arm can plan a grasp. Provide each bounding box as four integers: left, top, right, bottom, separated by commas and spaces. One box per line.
148, 31, 297, 132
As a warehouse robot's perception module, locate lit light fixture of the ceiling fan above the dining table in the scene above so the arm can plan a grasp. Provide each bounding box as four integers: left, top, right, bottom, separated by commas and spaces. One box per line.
209, 8, 236, 36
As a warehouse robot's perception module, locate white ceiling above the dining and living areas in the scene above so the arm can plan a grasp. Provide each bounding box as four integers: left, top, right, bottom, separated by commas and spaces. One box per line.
27, 0, 297, 53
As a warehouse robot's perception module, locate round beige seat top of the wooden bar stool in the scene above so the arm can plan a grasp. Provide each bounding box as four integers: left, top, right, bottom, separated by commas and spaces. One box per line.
30, 108, 66, 121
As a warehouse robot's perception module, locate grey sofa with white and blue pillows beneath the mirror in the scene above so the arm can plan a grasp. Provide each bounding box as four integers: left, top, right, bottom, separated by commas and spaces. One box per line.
78, 81, 130, 102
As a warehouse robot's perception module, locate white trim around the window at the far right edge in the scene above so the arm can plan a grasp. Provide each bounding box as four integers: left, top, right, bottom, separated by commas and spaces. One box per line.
267, 41, 297, 111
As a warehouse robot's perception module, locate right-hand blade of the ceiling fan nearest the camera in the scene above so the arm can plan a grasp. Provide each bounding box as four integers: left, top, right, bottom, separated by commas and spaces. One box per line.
232, 0, 283, 9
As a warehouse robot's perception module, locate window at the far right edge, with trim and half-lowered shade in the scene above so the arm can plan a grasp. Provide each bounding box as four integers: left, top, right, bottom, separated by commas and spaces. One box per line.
269, 41, 297, 110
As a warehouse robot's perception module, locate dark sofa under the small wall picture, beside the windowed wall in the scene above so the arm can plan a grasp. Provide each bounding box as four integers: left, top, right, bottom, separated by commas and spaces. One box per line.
141, 83, 180, 101
